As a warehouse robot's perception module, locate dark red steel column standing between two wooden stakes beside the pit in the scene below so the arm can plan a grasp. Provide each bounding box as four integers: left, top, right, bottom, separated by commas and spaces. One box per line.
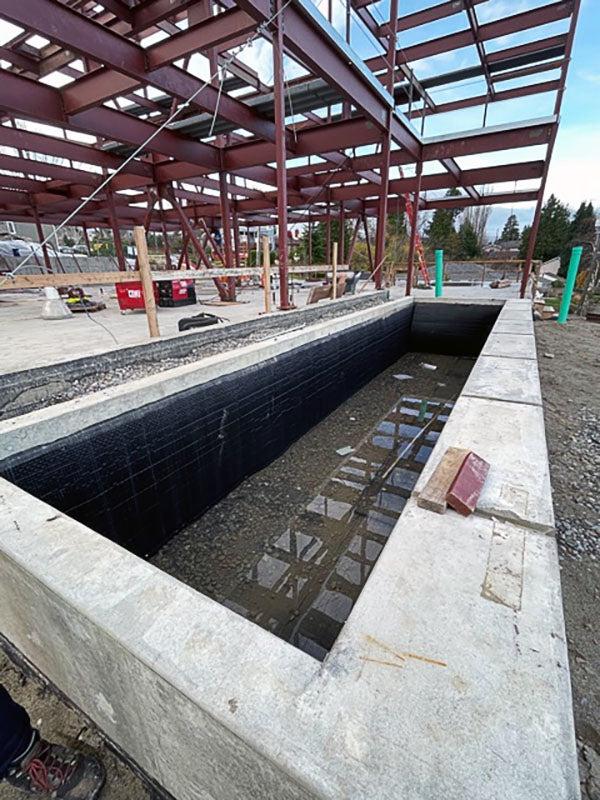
273, 0, 291, 311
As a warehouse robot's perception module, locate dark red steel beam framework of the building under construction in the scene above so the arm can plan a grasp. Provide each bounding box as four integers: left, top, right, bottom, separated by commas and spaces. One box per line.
0, 0, 580, 308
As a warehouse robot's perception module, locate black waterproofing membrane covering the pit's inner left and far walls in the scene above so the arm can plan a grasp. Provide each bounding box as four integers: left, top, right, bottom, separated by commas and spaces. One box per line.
0, 303, 499, 557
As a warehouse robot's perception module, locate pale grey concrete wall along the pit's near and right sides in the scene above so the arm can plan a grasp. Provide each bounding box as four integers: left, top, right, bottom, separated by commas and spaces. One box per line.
0, 301, 579, 800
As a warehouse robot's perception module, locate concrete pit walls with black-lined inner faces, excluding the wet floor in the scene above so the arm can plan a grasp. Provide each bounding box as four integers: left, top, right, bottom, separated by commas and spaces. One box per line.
0, 299, 579, 800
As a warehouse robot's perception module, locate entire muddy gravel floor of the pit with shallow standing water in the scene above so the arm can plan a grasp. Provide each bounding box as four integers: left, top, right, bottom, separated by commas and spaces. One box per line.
152, 353, 474, 659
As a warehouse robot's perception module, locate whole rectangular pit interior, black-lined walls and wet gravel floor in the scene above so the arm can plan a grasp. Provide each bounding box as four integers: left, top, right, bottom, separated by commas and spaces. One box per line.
0, 302, 499, 659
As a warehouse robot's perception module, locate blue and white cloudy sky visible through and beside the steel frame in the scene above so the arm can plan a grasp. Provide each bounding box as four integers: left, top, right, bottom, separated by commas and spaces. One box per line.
0, 0, 600, 236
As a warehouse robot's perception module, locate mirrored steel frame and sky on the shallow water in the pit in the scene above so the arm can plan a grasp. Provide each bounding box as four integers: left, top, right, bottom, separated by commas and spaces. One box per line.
222, 397, 453, 659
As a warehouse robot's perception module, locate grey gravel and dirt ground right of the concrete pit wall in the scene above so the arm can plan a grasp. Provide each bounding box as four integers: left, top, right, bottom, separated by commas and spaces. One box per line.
536, 318, 600, 800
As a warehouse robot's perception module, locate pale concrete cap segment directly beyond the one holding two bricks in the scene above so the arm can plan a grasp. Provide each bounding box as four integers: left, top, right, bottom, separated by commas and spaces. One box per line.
462, 356, 542, 406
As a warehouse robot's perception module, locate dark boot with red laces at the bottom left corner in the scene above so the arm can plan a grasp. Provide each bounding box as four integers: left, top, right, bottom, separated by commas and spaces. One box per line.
5, 739, 105, 800
